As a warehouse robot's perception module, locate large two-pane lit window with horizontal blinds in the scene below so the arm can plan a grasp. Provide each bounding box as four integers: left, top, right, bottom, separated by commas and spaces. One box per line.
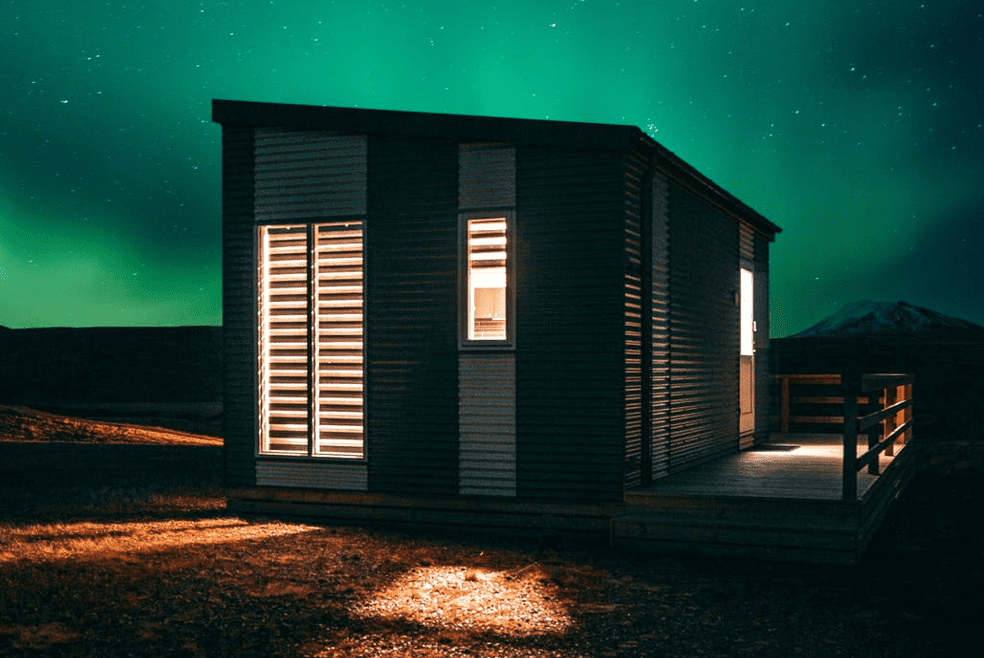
257, 221, 365, 459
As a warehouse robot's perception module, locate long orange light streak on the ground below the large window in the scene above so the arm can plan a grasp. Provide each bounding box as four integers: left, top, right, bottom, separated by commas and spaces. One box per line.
0, 519, 317, 564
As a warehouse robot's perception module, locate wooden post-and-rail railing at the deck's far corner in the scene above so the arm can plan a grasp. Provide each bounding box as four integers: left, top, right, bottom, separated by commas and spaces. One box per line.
773, 373, 914, 501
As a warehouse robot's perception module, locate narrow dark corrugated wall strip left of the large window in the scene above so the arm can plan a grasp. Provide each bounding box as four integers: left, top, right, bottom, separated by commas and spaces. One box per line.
222, 127, 257, 486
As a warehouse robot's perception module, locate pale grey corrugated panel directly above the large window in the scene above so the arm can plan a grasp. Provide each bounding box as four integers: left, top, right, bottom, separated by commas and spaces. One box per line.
255, 128, 367, 222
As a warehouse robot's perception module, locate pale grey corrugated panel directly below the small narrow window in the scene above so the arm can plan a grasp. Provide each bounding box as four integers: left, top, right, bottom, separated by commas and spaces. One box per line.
458, 352, 516, 496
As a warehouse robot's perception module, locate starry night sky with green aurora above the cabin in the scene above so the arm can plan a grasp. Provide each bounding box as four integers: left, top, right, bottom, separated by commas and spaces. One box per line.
0, 0, 984, 336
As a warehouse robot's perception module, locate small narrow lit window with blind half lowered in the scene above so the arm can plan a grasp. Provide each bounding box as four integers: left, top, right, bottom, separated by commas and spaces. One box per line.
465, 217, 510, 343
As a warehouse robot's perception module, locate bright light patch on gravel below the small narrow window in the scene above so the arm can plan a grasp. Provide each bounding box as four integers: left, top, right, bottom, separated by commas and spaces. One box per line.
355, 566, 570, 636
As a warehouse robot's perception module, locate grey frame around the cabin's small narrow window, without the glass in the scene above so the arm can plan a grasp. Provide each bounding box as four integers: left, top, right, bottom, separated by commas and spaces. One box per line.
458, 208, 516, 351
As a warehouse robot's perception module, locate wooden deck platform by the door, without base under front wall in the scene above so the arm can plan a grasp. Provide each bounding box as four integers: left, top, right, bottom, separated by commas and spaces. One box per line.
612, 435, 917, 564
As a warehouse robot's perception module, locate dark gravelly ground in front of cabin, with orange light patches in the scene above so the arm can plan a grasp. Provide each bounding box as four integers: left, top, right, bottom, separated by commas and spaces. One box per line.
0, 408, 984, 657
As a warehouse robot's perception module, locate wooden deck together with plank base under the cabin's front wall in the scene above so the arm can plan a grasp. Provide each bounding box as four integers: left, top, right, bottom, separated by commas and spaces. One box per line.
229, 435, 918, 564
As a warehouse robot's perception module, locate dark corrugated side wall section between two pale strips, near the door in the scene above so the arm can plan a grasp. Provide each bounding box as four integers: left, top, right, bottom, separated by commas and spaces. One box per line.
669, 181, 740, 472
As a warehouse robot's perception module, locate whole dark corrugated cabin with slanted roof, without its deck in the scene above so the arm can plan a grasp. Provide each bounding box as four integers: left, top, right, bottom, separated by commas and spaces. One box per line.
213, 101, 779, 518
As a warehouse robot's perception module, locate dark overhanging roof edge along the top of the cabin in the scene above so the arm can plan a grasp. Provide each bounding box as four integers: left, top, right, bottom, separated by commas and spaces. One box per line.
212, 99, 782, 241
